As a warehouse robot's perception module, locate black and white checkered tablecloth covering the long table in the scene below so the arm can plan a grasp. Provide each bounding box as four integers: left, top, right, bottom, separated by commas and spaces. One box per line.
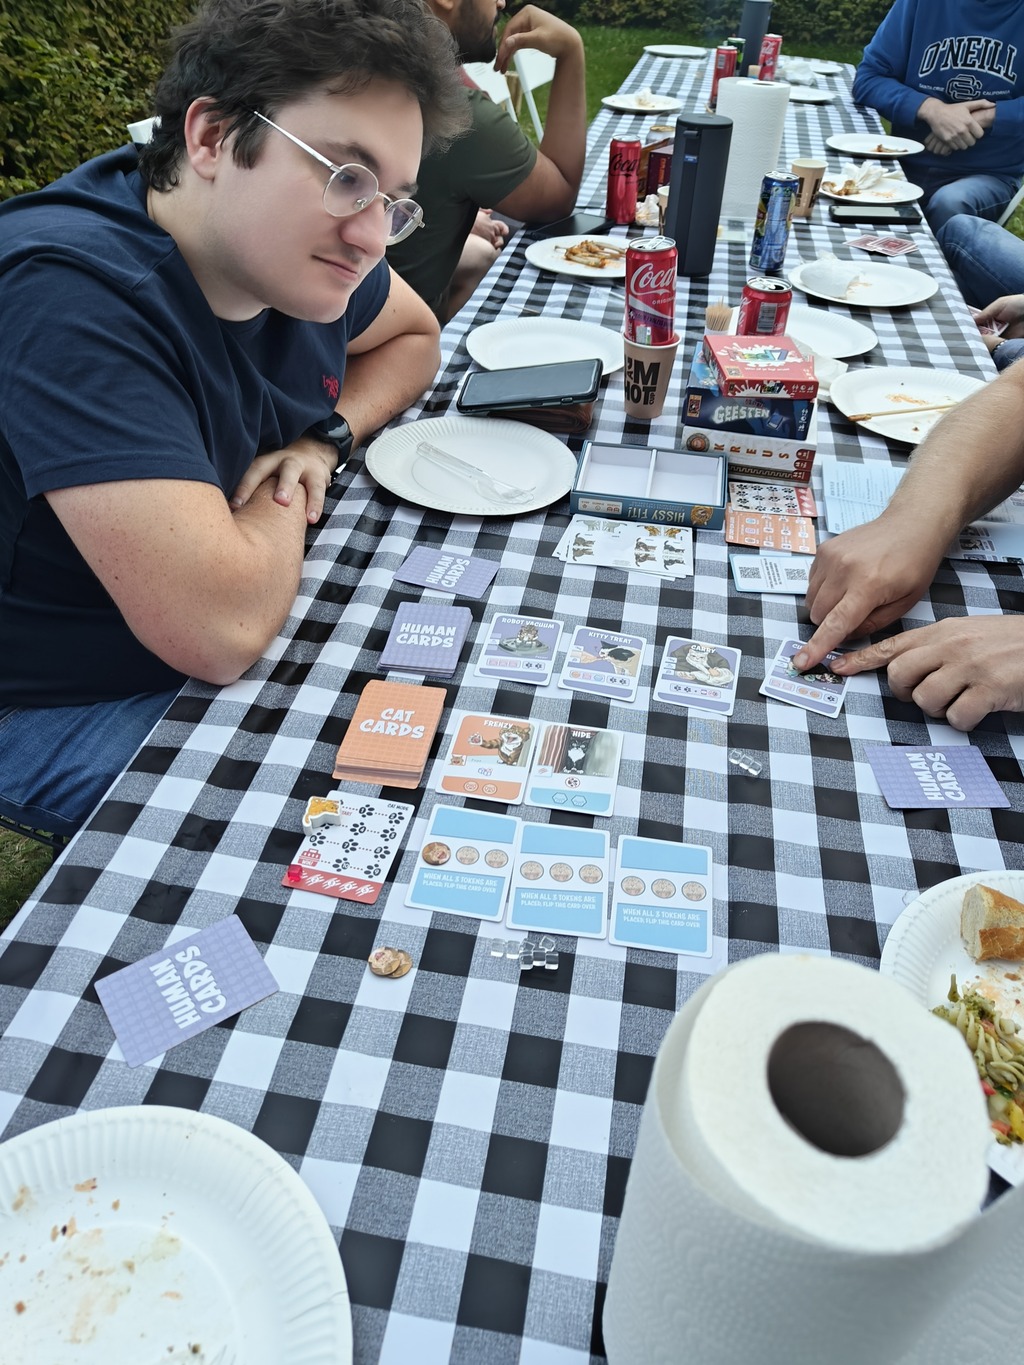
0, 57, 1024, 1365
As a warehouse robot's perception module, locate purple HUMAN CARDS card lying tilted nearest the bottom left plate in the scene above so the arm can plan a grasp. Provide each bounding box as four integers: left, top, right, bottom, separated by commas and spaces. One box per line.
96, 915, 277, 1066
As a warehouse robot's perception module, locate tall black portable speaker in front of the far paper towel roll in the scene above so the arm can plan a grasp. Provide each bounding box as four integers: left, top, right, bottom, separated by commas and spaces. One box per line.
665, 113, 732, 276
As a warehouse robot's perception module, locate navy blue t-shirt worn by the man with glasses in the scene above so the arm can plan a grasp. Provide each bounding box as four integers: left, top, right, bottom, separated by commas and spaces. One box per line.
0, 147, 389, 706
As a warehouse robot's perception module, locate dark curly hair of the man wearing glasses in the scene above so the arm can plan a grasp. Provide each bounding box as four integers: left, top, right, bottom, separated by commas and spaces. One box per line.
139, 0, 468, 190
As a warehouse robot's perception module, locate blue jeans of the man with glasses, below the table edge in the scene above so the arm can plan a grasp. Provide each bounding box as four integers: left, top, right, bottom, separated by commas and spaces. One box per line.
0, 688, 177, 835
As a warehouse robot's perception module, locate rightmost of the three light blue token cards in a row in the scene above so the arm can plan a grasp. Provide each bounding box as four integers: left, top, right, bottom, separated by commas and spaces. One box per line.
608, 837, 713, 957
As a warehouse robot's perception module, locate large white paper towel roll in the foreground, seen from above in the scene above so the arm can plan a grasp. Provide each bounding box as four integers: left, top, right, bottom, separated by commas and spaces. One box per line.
603, 956, 1024, 1365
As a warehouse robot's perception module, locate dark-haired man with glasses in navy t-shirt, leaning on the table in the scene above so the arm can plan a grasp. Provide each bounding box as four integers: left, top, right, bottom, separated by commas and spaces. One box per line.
0, 0, 466, 834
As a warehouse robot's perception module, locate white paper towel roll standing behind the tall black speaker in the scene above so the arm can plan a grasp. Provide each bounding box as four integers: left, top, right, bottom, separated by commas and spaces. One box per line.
715, 76, 789, 221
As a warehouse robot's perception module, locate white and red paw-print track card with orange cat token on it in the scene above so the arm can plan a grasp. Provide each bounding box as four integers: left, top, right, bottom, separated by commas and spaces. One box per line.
281, 792, 414, 905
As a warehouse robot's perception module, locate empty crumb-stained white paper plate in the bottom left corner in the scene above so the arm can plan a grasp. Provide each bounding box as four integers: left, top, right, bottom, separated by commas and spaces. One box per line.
0, 1106, 352, 1365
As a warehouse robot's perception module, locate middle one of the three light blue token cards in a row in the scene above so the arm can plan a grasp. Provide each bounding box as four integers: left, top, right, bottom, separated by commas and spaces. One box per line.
505, 824, 609, 938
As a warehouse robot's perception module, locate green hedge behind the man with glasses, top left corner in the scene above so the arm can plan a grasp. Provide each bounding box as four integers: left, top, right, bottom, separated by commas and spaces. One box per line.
0, 0, 193, 199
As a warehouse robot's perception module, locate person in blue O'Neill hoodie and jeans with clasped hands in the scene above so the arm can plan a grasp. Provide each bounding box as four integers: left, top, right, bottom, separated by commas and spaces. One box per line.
853, 0, 1024, 231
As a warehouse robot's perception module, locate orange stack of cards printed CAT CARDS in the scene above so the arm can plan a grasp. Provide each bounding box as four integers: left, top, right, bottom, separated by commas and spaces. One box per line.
335, 683, 448, 788
